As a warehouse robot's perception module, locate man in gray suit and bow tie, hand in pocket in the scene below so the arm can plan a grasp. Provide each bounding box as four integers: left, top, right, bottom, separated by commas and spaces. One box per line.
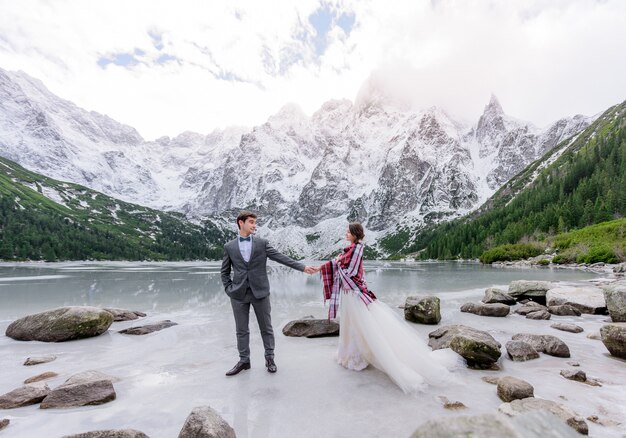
221, 211, 315, 376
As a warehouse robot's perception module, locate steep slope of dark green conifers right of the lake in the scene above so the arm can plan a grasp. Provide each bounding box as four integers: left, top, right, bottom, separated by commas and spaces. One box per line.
381, 102, 626, 259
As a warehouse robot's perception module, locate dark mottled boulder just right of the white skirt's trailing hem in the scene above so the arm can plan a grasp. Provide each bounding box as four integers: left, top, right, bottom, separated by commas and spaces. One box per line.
428, 325, 502, 369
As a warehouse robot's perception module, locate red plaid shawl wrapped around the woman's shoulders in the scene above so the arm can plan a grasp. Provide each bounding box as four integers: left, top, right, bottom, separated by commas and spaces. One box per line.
320, 243, 376, 319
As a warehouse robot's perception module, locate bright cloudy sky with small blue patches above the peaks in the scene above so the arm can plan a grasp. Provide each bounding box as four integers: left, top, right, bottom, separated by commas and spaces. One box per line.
0, 0, 626, 140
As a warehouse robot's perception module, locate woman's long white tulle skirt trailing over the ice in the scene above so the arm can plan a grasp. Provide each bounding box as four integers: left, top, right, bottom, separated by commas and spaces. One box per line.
337, 291, 462, 393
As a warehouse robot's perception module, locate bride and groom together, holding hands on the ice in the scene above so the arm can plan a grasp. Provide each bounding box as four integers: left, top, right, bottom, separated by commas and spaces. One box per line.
221, 211, 457, 392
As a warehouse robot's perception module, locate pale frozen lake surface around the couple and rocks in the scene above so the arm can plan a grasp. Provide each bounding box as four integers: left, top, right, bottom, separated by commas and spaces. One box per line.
0, 262, 626, 438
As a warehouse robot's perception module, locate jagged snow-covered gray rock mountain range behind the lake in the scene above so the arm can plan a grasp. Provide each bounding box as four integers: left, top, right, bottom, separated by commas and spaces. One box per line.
0, 69, 592, 256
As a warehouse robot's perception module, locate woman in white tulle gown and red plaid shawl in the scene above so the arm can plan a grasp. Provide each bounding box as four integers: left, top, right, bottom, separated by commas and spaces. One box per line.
316, 223, 458, 393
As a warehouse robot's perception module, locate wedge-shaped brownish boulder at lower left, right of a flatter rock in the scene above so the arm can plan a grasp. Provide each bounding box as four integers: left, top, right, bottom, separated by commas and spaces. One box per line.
41, 371, 117, 409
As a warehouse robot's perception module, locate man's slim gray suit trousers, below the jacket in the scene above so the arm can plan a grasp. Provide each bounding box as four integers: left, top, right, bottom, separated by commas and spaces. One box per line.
230, 289, 274, 362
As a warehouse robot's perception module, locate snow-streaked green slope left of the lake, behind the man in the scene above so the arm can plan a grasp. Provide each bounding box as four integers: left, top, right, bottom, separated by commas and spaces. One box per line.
0, 158, 230, 261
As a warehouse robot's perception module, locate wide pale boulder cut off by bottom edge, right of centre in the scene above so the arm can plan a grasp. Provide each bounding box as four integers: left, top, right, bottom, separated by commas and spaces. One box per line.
411, 411, 579, 438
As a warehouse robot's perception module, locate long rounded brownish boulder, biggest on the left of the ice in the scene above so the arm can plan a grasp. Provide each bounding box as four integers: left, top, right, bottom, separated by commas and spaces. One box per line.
6, 306, 113, 342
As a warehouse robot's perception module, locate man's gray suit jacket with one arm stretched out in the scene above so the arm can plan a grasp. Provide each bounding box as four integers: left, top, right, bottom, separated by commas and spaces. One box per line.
221, 237, 304, 300
